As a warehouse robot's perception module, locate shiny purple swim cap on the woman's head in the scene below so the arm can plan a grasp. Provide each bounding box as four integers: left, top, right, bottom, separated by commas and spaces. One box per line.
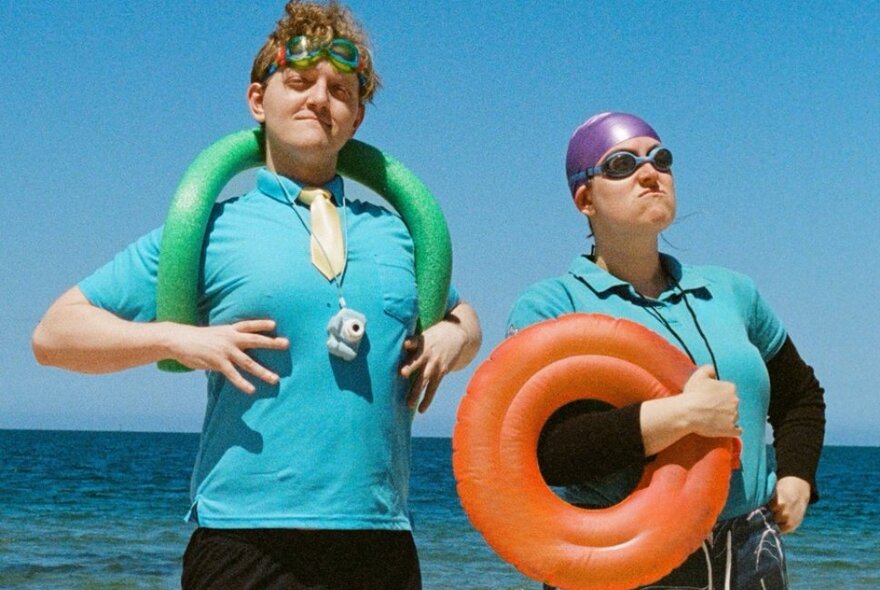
565, 113, 660, 194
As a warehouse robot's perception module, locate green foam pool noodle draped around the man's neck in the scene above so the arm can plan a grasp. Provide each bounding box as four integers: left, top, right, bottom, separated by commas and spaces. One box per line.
156, 129, 452, 372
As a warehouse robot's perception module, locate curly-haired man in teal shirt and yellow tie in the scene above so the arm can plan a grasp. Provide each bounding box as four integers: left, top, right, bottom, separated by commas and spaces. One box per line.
33, 1, 481, 590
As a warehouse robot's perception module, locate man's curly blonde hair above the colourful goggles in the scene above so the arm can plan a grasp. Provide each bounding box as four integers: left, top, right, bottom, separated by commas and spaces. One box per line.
251, 0, 382, 104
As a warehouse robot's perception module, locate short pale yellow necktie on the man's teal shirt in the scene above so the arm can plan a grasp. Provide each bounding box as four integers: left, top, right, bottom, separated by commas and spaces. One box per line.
297, 187, 345, 279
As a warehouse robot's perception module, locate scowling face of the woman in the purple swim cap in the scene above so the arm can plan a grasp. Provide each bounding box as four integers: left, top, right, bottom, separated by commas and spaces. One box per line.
575, 137, 675, 238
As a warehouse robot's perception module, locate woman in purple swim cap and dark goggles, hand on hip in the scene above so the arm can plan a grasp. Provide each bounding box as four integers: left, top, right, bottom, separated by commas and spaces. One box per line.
508, 113, 825, 590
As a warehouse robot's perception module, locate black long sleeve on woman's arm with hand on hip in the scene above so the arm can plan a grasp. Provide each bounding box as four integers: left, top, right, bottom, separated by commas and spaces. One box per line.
767, 338, 825, 502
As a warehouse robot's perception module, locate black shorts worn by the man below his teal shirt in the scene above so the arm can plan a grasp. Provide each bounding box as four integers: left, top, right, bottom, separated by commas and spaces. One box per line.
181, 528, 422, 590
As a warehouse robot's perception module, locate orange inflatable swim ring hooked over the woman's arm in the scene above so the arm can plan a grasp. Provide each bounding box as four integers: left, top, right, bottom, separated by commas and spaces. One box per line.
452, 314, 739, 590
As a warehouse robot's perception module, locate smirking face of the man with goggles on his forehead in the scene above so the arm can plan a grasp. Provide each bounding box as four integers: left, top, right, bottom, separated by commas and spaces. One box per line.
248, 59, 364, 170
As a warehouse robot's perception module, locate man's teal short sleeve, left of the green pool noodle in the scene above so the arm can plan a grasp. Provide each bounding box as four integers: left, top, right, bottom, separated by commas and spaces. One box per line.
78, 228, 162, 322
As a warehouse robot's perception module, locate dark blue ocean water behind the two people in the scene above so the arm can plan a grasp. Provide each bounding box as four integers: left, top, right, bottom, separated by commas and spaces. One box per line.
0, 430, 880, 590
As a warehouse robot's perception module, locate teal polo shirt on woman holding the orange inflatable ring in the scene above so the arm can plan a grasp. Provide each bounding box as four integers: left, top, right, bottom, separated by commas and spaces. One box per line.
508, 254, 786, 519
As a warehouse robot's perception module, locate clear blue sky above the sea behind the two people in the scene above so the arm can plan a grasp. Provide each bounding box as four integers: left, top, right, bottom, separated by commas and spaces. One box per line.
0, 0, 880, 445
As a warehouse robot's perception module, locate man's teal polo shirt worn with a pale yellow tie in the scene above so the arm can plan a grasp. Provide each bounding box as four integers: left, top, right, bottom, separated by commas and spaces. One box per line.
79, 170, 458, 530
